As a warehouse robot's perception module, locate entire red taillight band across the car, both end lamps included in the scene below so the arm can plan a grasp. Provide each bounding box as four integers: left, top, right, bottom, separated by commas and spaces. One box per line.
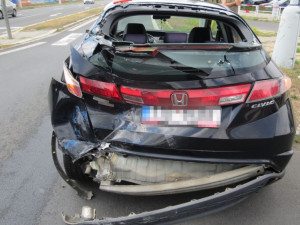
68, 74, 291, 107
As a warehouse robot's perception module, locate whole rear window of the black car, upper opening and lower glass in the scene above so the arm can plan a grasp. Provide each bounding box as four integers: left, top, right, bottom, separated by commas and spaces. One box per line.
89, 12, 270, 80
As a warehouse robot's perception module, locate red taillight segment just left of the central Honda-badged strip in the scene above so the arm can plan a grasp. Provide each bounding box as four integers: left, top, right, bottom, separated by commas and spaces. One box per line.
80, 77, 122, 101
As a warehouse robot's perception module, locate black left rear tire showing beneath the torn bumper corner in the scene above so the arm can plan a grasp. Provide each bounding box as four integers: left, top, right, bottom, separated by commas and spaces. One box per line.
63, 154, 87, 181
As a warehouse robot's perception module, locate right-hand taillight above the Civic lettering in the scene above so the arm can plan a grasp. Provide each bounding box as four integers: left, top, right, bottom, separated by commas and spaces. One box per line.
247, 76, 292, 102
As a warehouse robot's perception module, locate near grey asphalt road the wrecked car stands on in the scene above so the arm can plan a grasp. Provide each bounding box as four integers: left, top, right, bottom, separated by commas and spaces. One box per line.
0, 5, 300, 225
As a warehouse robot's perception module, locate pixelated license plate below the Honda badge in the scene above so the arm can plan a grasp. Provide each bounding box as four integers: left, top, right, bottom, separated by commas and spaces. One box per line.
142, 106, 221, 128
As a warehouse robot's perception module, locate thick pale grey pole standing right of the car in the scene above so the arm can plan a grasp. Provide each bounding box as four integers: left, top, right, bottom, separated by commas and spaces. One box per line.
272, 0, 300, 69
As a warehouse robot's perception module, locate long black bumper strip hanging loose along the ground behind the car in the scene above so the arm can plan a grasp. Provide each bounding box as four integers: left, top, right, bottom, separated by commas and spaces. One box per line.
62, 172, 284, 225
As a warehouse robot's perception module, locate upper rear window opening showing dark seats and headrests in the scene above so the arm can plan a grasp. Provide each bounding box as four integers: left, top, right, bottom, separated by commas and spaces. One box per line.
111, 15, 242, 44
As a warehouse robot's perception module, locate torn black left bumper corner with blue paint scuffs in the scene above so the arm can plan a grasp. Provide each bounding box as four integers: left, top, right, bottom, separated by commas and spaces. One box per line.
49, 79, 100, 160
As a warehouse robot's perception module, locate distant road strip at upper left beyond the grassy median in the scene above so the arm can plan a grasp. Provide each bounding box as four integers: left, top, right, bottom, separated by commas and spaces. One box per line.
0, 0, 111, 34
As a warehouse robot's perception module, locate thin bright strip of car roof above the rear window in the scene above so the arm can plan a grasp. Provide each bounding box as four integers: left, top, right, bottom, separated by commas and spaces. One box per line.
105, 0, 230, 11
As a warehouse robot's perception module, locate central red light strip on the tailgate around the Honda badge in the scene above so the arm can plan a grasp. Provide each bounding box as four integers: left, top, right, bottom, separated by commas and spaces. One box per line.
120, 84, 251, 107
